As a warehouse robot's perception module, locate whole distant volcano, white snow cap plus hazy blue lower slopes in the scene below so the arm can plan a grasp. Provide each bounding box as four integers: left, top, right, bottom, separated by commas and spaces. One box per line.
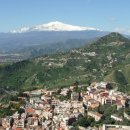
0, 22, 108, 58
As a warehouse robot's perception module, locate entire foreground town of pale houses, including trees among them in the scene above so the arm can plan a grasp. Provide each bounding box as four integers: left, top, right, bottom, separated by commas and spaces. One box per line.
1, 82, 130, 130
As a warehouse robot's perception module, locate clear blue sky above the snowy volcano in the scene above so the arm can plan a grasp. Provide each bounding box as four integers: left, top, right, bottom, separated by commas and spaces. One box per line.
0, 0, 130, 34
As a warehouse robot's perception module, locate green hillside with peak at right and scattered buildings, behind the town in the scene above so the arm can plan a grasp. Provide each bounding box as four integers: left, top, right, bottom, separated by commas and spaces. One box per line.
0, 33, 130, 92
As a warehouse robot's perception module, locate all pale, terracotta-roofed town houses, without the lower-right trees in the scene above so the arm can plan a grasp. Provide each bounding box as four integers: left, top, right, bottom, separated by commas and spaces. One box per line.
2, 82, 130, 130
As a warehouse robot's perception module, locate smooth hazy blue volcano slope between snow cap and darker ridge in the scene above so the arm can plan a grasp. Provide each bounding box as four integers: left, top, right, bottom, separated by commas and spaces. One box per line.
0, 31, 107, 53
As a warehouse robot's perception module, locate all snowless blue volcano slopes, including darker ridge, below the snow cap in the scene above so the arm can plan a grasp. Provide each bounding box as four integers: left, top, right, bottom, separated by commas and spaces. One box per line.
0, 30, 108, 62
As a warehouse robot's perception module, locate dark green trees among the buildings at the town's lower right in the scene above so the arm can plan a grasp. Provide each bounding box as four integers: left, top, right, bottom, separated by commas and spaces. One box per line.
73, 105, 130, 130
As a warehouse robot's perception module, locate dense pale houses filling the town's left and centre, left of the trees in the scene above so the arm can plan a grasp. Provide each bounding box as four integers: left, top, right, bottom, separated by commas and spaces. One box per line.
2, 89, 84, 130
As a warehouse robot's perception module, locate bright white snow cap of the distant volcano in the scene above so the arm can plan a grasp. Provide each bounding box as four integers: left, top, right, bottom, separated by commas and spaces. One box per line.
11, 21, 99, 33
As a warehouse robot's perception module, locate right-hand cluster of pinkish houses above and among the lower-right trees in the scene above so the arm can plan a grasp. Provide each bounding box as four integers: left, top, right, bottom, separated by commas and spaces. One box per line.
83, 82, 130, 121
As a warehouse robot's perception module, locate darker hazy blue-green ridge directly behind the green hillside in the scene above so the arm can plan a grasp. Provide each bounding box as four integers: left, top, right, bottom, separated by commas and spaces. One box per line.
17, 39, 91, 58
